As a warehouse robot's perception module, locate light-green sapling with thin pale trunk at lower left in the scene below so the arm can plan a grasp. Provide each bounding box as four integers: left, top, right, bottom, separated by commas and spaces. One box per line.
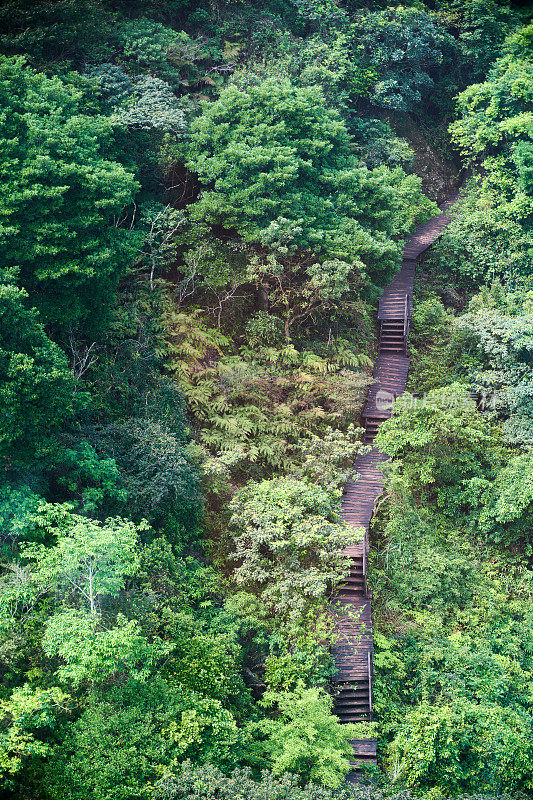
13, 504, 169, 687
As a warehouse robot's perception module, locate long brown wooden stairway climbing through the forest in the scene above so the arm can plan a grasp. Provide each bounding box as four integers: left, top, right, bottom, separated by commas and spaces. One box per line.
331, 193, 459, 781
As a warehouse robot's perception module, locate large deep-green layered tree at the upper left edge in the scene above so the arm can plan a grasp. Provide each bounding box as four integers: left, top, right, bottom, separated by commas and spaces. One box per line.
0, 58, 137, 327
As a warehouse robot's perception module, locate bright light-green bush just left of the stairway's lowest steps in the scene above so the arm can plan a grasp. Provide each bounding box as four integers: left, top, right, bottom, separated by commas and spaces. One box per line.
253, 683, 355, 787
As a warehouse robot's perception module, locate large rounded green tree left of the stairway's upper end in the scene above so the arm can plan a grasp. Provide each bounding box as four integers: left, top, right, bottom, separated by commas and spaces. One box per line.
188, 79, 429, 290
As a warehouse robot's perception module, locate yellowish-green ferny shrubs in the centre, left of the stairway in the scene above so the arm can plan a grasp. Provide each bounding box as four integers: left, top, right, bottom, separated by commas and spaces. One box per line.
165, 313, 368, 474
